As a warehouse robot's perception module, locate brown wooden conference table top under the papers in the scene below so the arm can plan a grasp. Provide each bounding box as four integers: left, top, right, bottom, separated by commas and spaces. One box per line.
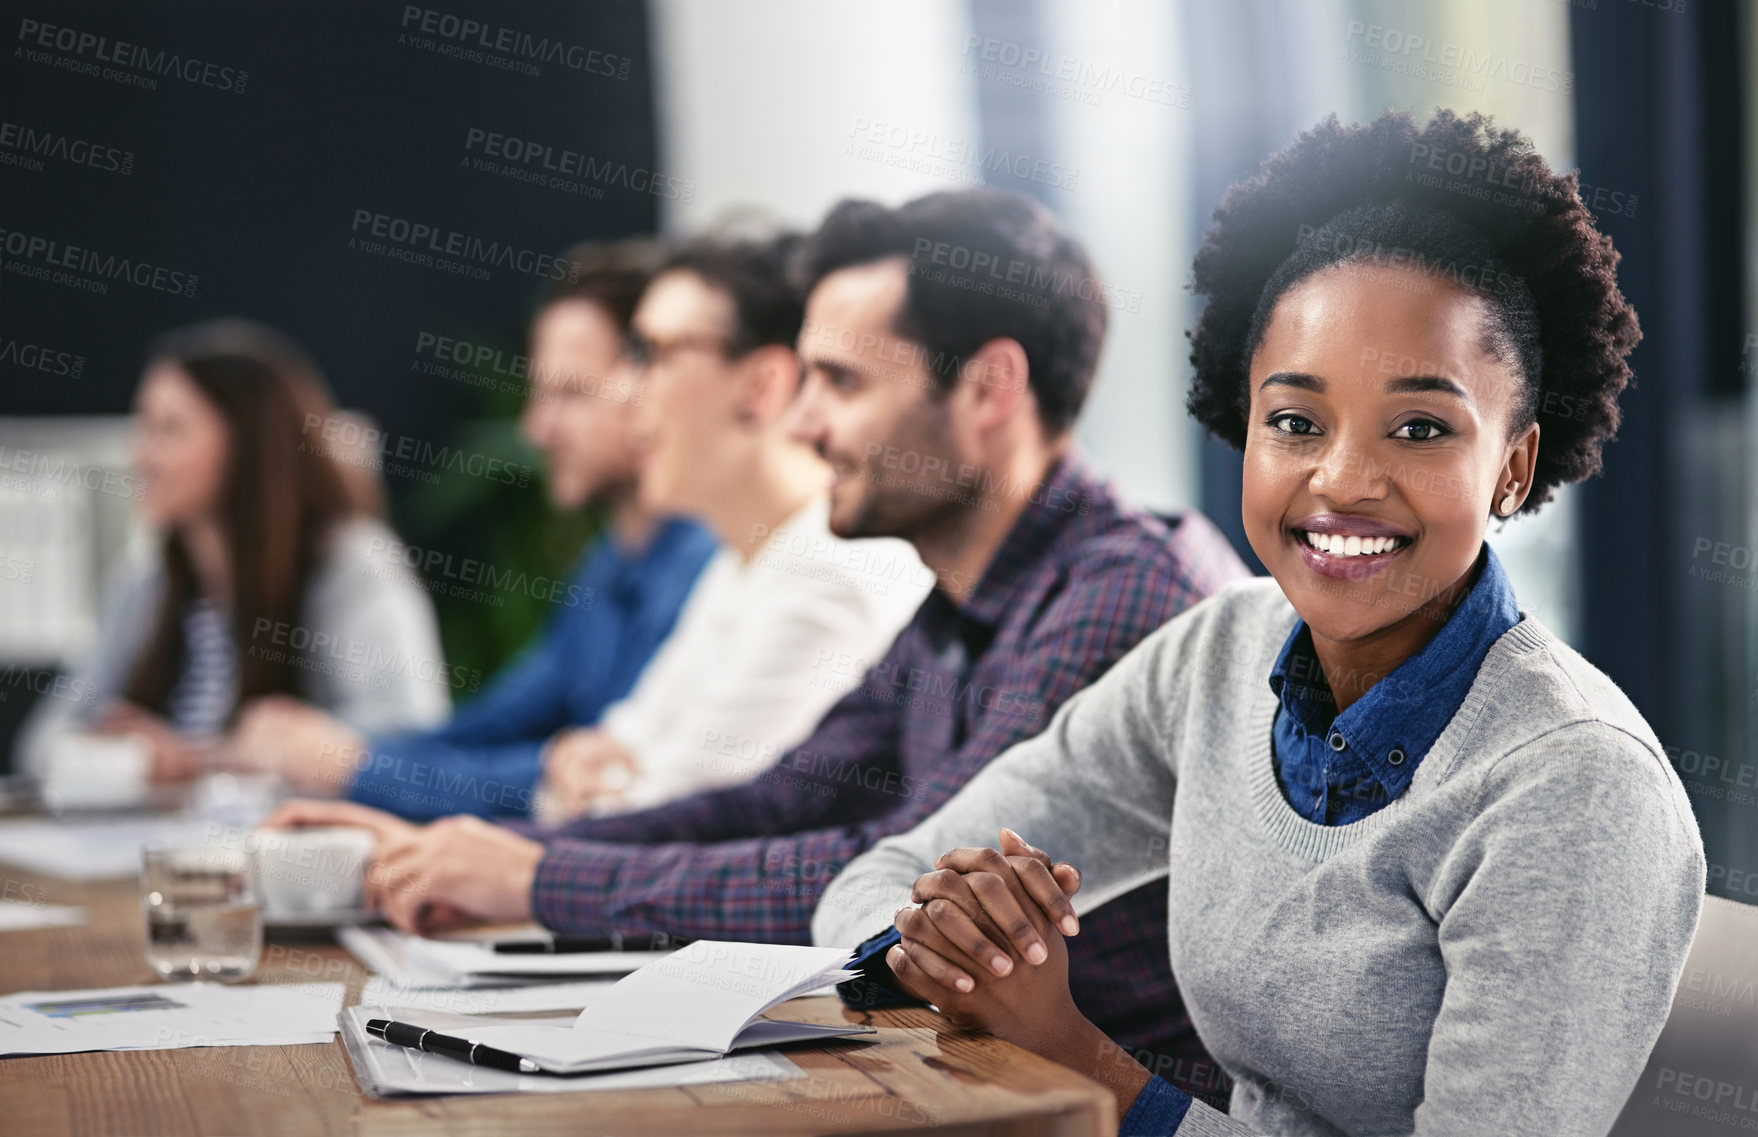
0, 866, 1116, 1137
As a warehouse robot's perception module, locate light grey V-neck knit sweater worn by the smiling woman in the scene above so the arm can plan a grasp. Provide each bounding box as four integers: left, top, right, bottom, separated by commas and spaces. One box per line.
812, 578, 1704, 1137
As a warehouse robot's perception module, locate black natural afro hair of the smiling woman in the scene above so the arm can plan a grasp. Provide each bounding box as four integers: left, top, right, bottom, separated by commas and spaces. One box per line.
1187, 109, 1642, 513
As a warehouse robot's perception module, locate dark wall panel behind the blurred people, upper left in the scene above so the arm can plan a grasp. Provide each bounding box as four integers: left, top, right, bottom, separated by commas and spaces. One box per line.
0, 0, 666, 453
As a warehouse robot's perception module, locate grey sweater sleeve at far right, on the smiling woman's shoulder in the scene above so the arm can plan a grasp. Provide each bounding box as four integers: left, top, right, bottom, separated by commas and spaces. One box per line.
1392, 722, 1705, 1137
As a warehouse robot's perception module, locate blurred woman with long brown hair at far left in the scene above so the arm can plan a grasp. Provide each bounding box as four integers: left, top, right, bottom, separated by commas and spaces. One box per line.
19, 320, 450, 797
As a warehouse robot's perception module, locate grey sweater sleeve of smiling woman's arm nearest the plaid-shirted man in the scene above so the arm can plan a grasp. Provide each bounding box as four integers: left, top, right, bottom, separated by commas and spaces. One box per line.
812, 599, 1213, 947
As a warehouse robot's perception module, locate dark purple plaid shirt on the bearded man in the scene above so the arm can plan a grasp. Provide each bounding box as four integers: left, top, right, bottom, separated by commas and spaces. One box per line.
531, 457, 1246, 1079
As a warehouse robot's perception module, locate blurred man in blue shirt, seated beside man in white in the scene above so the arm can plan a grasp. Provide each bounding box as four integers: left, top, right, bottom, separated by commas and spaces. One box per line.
239, 243, 716, 819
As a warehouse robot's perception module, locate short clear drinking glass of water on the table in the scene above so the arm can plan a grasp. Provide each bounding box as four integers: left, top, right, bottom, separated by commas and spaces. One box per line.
141, 845, 262, 982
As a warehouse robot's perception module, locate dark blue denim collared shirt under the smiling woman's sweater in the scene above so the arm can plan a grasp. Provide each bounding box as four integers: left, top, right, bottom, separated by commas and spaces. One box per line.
1269, 543, 1521, 826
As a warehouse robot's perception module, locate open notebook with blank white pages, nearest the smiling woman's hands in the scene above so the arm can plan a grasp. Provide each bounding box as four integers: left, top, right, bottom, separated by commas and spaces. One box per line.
420, 940, 872, 1074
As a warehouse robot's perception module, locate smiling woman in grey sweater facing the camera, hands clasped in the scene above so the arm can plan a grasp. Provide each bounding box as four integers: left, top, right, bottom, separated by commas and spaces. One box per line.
814, 111, 1704, 1137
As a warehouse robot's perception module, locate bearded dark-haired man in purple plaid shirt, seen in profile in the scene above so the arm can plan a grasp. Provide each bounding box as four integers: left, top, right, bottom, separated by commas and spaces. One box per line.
260, 190, 1246, 1091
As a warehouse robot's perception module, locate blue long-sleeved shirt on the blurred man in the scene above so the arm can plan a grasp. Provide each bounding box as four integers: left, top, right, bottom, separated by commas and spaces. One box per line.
348, 520, 716, 821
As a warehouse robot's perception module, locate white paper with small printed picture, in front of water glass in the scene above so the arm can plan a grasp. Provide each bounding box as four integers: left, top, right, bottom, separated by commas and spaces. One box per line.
0, 982, 345, 1054
